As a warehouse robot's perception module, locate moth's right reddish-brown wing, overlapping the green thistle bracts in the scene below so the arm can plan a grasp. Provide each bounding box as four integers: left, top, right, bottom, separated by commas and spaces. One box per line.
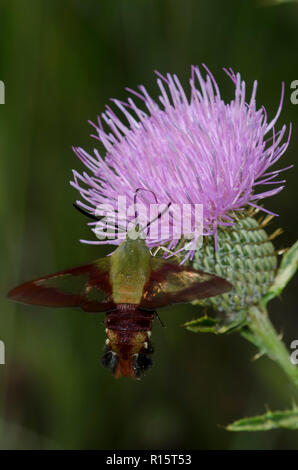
140, 259, 233, 309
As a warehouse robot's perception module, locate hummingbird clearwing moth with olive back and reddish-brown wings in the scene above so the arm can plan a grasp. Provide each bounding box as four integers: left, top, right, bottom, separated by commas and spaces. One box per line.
8, 197, 233, 379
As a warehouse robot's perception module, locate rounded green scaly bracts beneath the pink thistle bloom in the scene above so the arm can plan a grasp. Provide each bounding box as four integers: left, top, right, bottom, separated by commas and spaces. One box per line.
193, 215, 277, 313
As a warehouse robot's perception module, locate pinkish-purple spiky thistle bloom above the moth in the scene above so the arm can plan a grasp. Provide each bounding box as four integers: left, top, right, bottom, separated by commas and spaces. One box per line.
71, 66, 291, 258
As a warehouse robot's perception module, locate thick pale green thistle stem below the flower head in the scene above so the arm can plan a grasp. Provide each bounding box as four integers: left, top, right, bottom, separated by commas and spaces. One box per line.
241, 306, 298, 388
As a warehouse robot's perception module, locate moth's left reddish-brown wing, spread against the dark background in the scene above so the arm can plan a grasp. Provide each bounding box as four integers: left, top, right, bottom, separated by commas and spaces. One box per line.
8, 258, 115, 312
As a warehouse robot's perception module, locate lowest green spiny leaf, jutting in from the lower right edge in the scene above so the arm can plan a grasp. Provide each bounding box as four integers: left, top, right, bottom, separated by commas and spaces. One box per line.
226, 406, 298, 431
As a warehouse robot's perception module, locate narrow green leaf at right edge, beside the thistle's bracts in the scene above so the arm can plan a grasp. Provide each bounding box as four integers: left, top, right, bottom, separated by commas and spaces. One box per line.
262, 240, 298, 305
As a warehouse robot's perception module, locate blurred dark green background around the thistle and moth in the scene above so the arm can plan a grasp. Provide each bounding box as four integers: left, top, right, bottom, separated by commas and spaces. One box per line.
0, 0, 298, 449
